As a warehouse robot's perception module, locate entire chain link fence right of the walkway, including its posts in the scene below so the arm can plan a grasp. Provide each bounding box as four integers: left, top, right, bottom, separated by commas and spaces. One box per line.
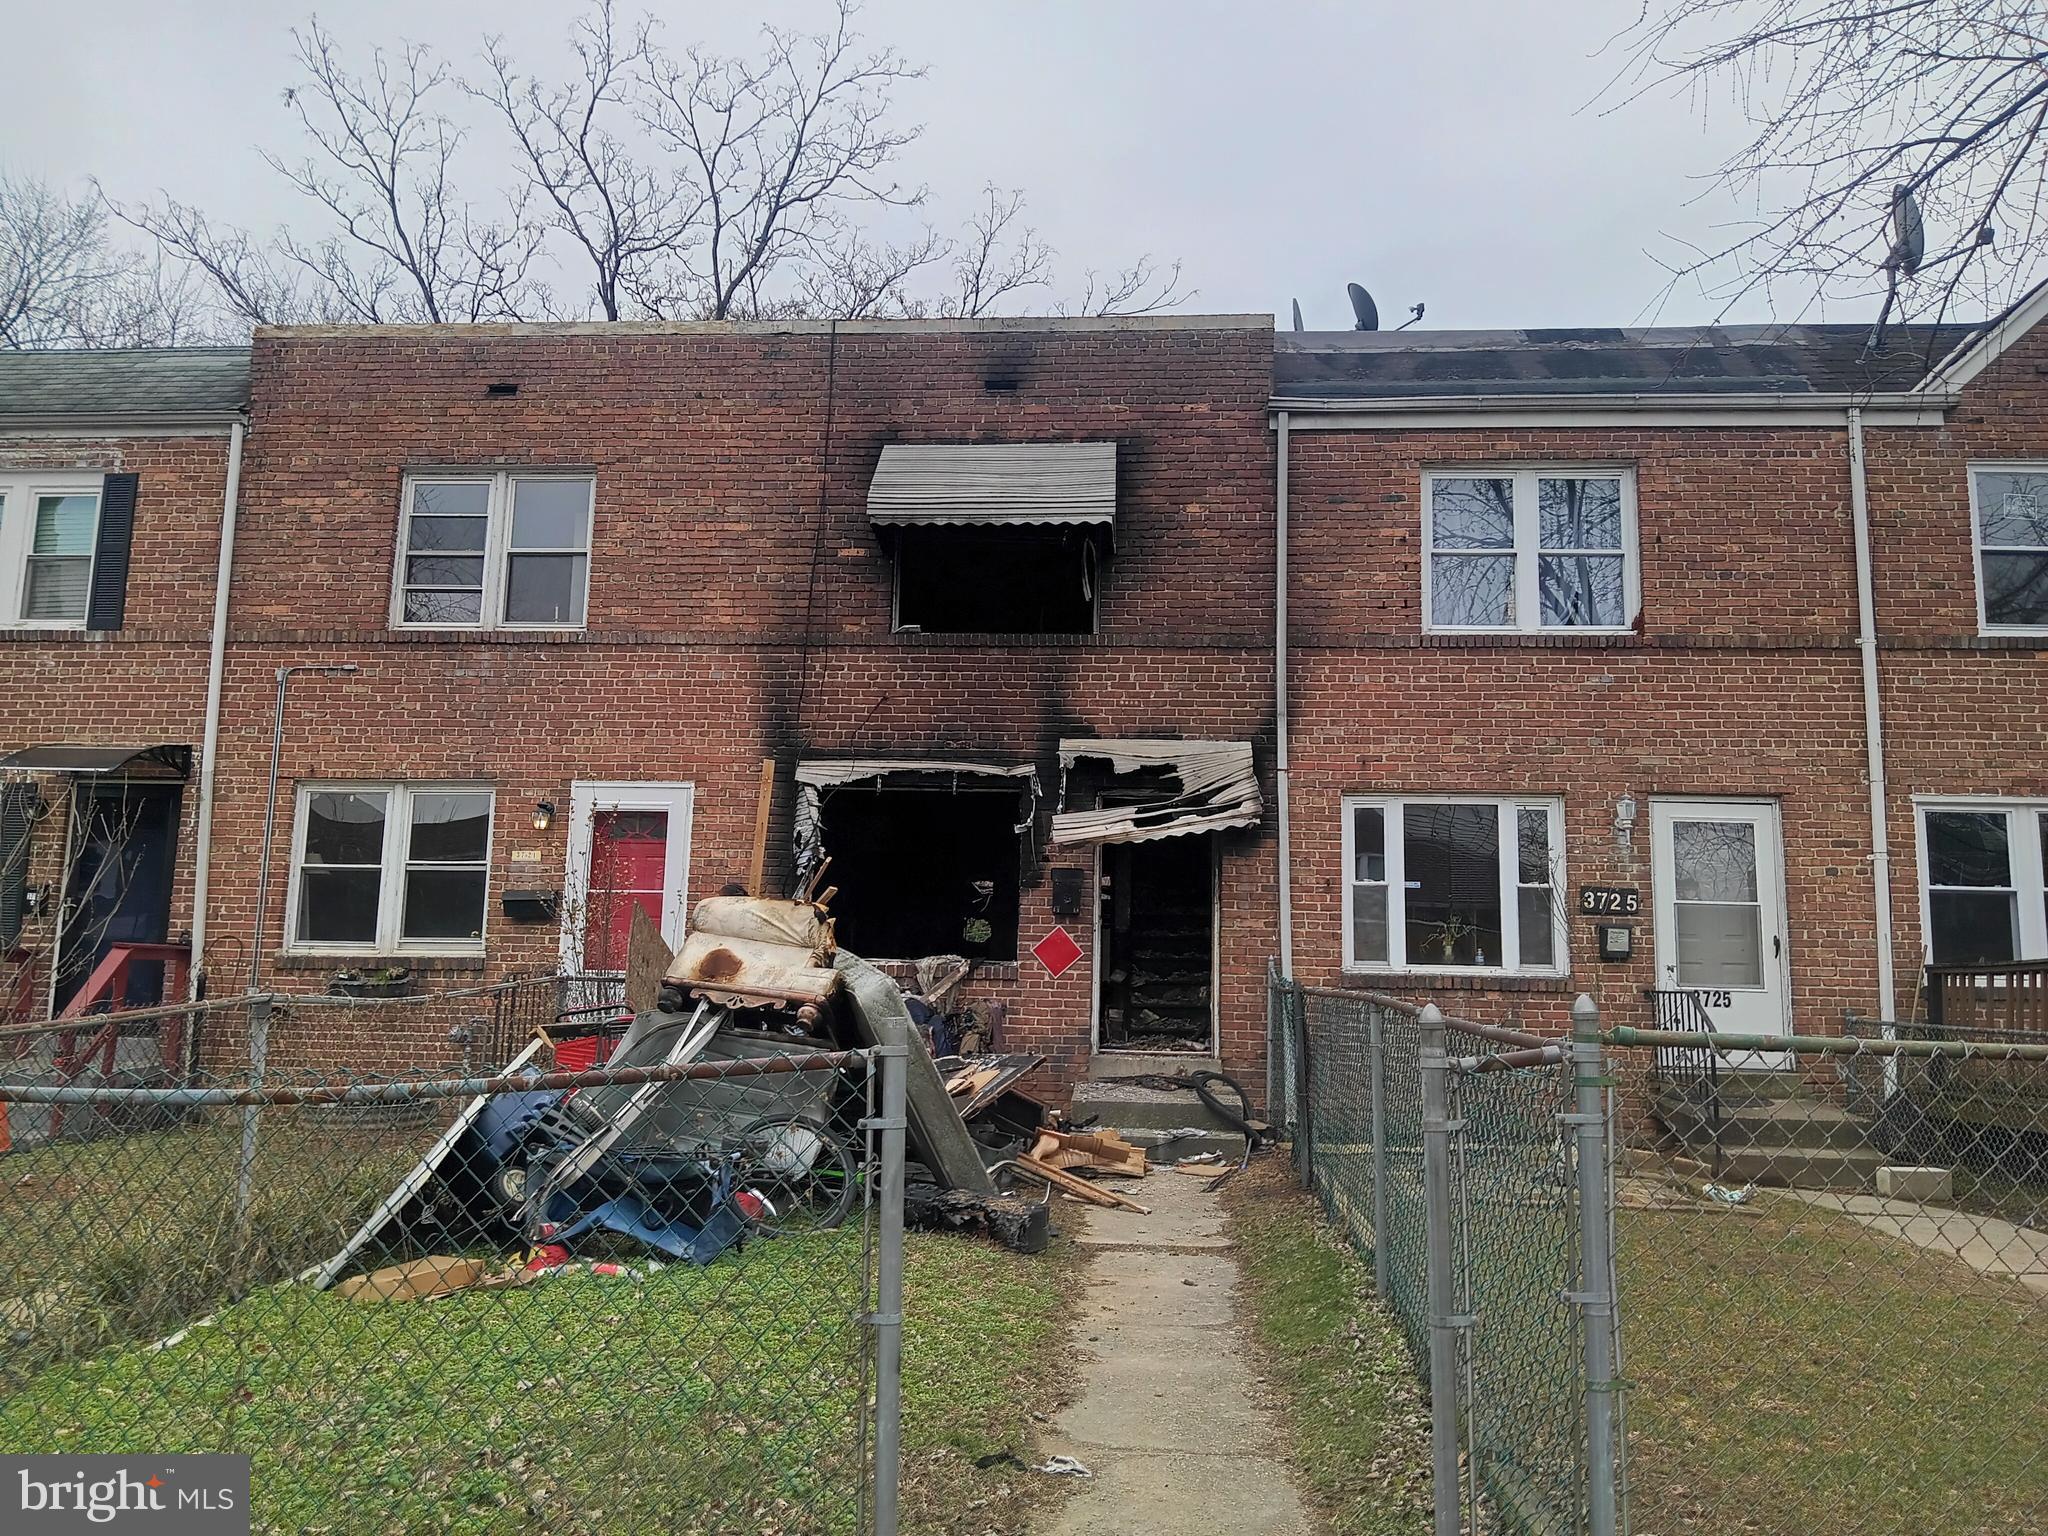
1270, 977, 2048, 1536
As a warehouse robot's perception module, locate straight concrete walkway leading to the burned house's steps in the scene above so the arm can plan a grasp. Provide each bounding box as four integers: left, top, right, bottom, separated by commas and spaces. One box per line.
1038, 1169, 1309, 1536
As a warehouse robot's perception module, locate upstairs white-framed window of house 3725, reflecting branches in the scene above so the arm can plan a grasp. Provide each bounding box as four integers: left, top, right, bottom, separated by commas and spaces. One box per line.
1421, 469, 1638, 633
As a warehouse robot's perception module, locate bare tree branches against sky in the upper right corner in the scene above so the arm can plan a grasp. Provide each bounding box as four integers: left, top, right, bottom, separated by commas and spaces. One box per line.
1604, 0, 2048, 317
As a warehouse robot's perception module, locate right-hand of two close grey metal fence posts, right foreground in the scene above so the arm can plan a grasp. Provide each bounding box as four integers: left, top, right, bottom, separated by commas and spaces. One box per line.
1563, 991, 1620, 1536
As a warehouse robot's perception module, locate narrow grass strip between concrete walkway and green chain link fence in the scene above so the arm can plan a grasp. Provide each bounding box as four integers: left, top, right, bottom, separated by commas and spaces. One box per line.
1223, 1157, 1430, 1536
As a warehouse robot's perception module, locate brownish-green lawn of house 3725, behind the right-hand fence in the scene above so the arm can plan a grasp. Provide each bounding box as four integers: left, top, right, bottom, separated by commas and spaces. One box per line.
1618, 1194, 2048, 1536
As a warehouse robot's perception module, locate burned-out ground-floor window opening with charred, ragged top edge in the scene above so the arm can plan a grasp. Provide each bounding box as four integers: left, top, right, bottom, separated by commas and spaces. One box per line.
797, 760, 1038, 961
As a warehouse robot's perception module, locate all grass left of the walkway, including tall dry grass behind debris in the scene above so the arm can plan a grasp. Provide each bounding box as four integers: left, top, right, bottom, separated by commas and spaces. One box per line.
0, 1116, 1071, 1536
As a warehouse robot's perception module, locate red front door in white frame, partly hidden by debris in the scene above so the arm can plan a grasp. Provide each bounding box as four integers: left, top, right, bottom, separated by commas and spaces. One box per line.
561, 782, 692, 975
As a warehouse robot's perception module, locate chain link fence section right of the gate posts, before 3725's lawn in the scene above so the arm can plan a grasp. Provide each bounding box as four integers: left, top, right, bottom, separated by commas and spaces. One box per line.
1612, 1008, 2048, 1536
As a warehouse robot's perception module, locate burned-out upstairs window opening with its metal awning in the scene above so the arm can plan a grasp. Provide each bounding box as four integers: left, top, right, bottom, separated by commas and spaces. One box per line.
868, 442, 1116, 635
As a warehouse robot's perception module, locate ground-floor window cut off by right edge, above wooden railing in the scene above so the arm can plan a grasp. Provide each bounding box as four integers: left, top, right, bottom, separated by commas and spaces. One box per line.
1919, 801, 2048, 965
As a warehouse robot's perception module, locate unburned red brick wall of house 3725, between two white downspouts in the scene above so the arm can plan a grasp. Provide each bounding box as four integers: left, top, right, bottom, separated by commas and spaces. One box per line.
1290, 428, 1874, 1030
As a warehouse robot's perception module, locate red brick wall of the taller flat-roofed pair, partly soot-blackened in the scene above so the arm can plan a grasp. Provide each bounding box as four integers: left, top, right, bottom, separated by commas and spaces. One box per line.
195, 326, 1276, 1090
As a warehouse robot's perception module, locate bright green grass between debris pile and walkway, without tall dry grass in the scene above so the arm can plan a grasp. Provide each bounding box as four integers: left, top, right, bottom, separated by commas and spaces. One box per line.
0, 1229, 1065, 1536
